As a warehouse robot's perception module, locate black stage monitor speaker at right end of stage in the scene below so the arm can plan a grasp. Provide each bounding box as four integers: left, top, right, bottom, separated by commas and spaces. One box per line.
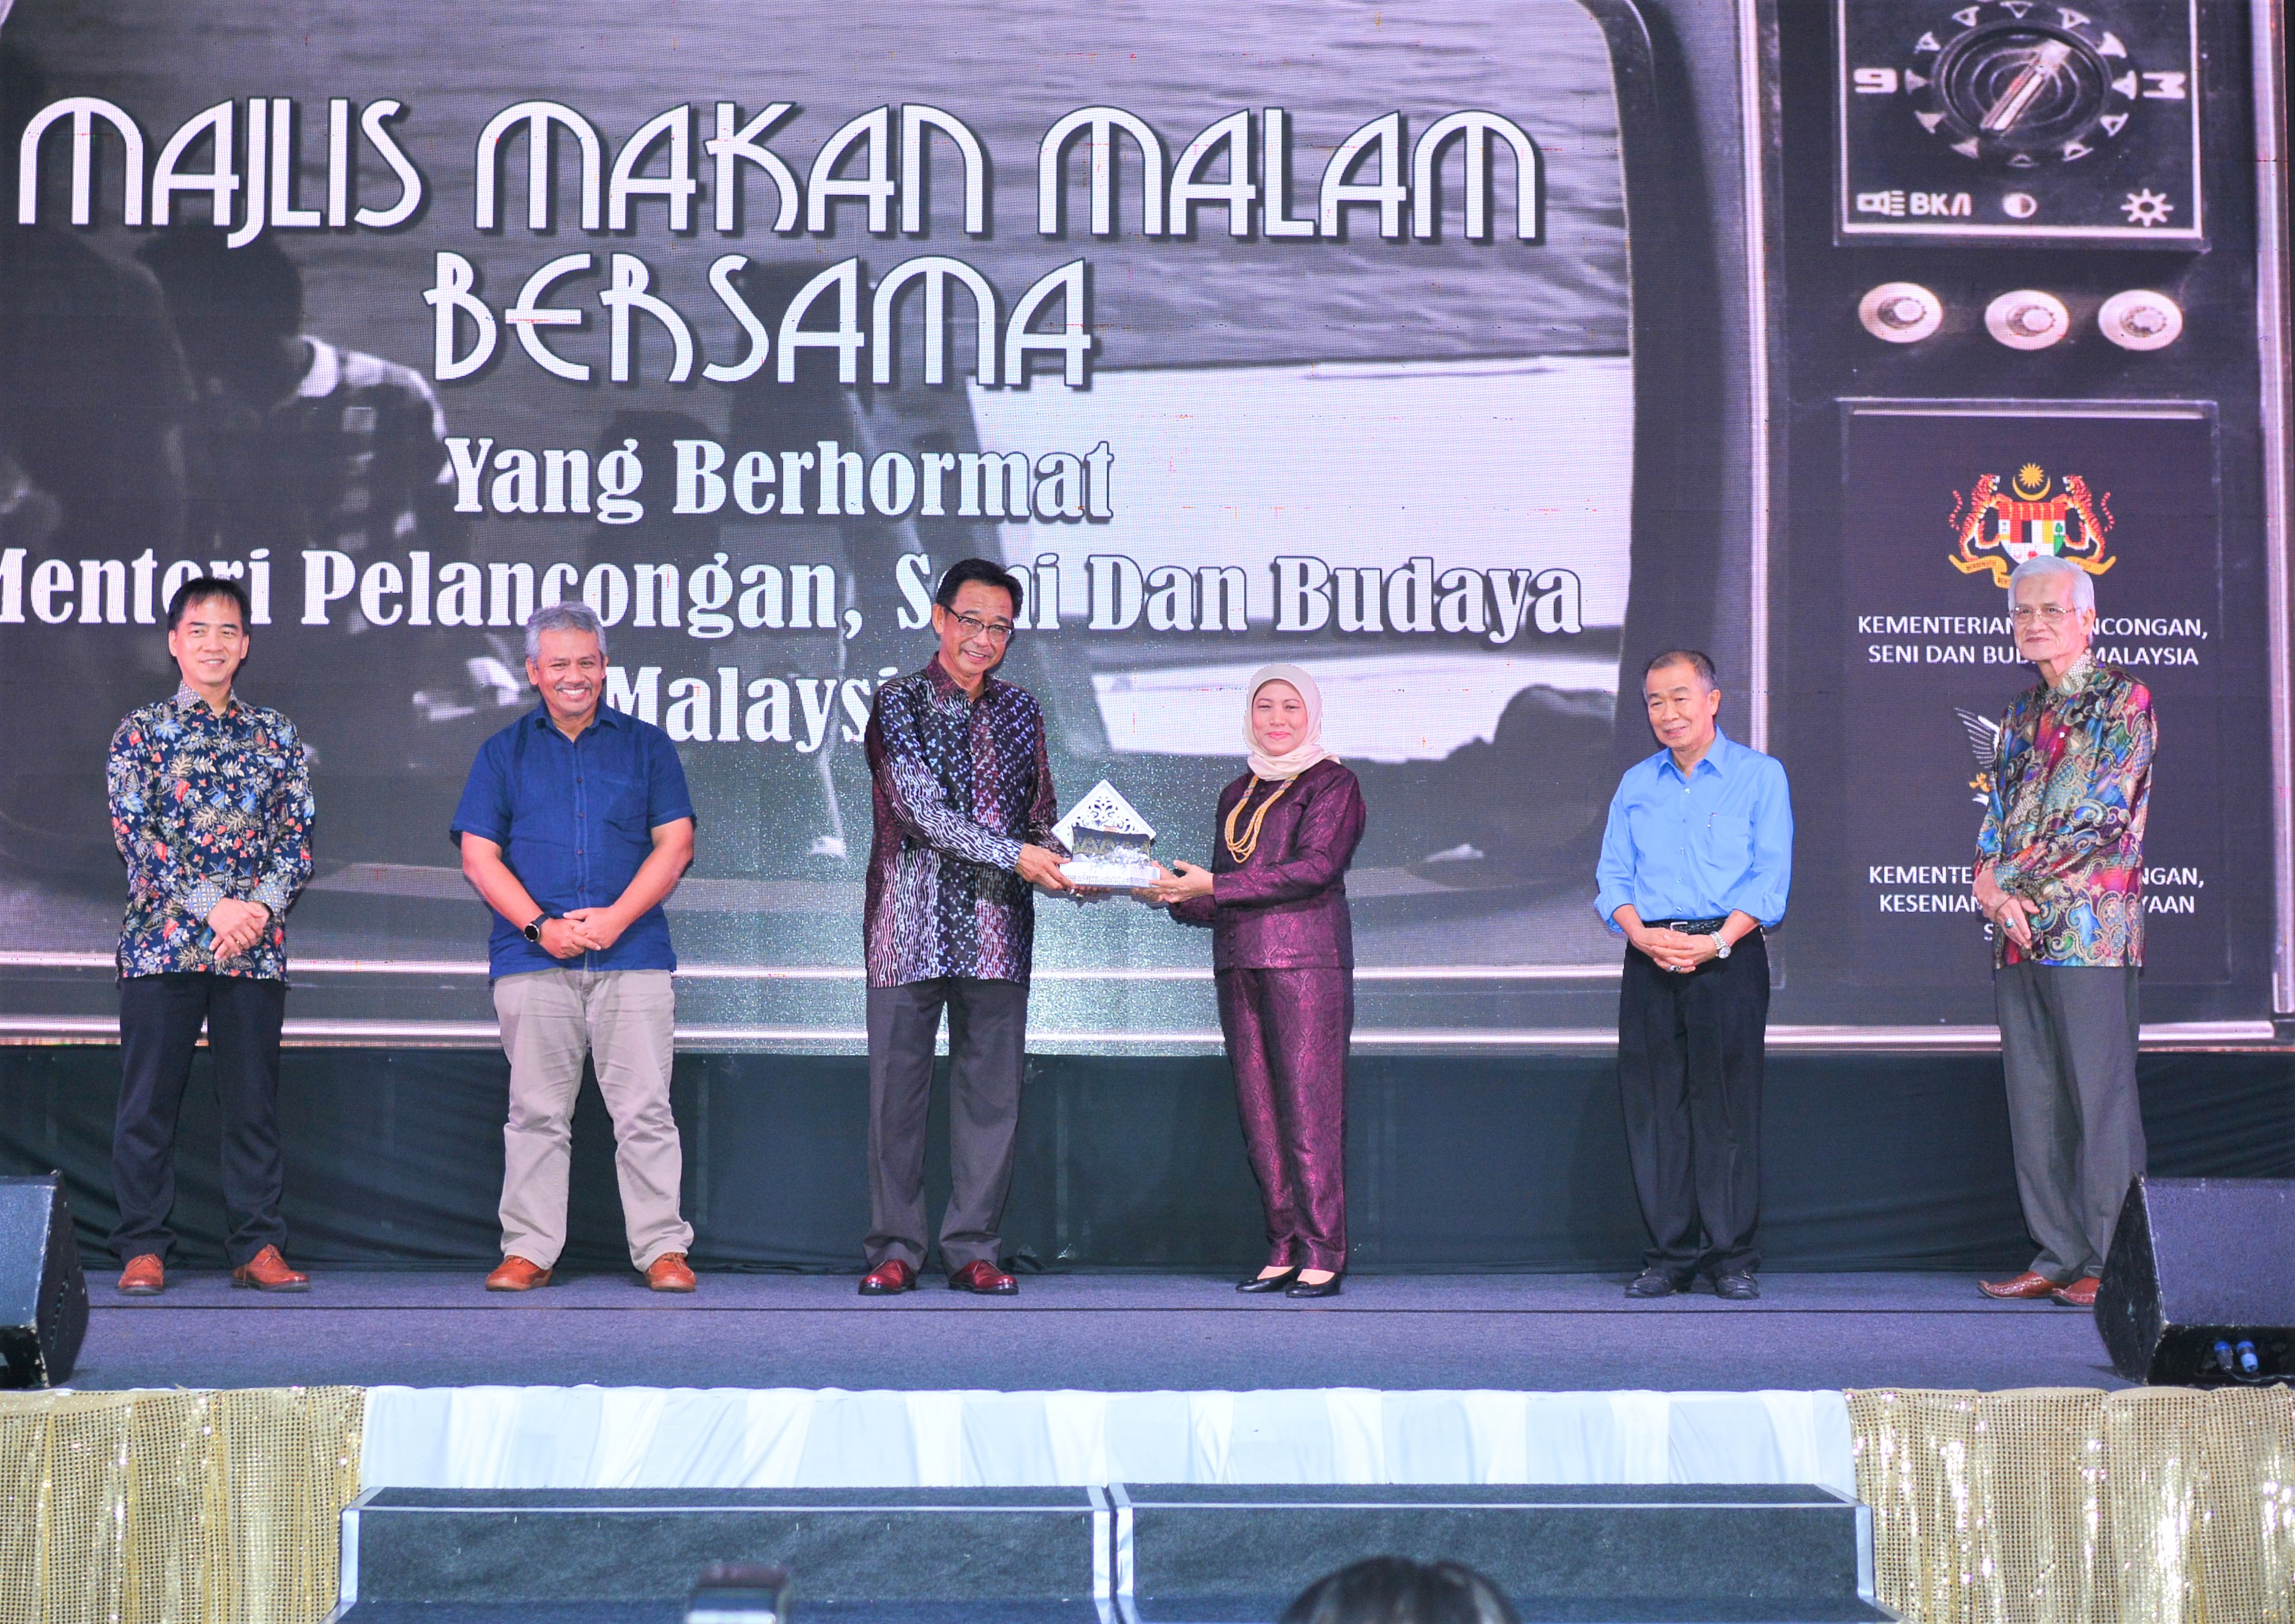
2096, 1174, 2295, 1388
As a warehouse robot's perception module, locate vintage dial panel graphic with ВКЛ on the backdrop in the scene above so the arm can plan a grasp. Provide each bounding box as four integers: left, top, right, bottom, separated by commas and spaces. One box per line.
1836, 0, 2201, 243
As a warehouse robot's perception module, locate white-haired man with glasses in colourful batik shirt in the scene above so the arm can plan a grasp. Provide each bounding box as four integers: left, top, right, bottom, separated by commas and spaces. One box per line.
1976, 555, 2157, 1308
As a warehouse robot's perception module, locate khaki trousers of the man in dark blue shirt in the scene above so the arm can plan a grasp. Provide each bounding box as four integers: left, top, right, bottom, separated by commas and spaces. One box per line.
494, 970, 693, 1269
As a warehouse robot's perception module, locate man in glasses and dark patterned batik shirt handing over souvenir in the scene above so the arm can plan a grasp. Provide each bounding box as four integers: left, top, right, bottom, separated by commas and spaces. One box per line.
861, 557, 1072, 1296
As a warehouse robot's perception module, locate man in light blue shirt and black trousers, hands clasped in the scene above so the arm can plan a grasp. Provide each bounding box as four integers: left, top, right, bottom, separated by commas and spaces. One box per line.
1593, 649, 1792, 1300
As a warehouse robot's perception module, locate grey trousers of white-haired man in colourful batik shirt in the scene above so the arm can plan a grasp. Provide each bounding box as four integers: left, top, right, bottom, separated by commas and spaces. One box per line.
1992, 963, 2143, 1285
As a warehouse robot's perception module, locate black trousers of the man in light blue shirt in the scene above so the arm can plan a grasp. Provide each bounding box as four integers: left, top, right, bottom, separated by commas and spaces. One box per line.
1618, 932, 1770, 1282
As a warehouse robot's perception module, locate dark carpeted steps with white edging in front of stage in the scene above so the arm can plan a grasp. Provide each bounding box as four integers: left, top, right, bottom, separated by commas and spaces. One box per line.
338, 1484, 1889, 1624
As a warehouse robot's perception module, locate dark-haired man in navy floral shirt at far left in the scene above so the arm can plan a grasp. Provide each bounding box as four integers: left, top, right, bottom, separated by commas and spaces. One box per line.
106, 576, 314, 1296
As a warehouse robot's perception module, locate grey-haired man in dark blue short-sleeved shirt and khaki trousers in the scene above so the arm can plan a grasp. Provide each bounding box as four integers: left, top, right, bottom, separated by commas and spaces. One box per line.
452, 603, 693, 1291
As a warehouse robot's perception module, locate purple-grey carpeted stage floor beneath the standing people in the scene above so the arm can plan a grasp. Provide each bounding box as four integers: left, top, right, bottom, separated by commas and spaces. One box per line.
71, 1271, 2123, 1392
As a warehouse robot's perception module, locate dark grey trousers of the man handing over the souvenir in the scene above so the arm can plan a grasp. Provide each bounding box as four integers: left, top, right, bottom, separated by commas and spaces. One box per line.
867, 975, 1028, 1273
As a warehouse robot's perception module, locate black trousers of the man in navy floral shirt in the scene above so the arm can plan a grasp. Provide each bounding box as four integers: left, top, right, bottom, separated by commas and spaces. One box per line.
113, 970, 287, 1269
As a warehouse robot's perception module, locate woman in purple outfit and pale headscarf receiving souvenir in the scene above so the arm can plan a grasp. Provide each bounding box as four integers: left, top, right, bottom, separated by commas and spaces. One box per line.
1152, 666, 1363, 1296
